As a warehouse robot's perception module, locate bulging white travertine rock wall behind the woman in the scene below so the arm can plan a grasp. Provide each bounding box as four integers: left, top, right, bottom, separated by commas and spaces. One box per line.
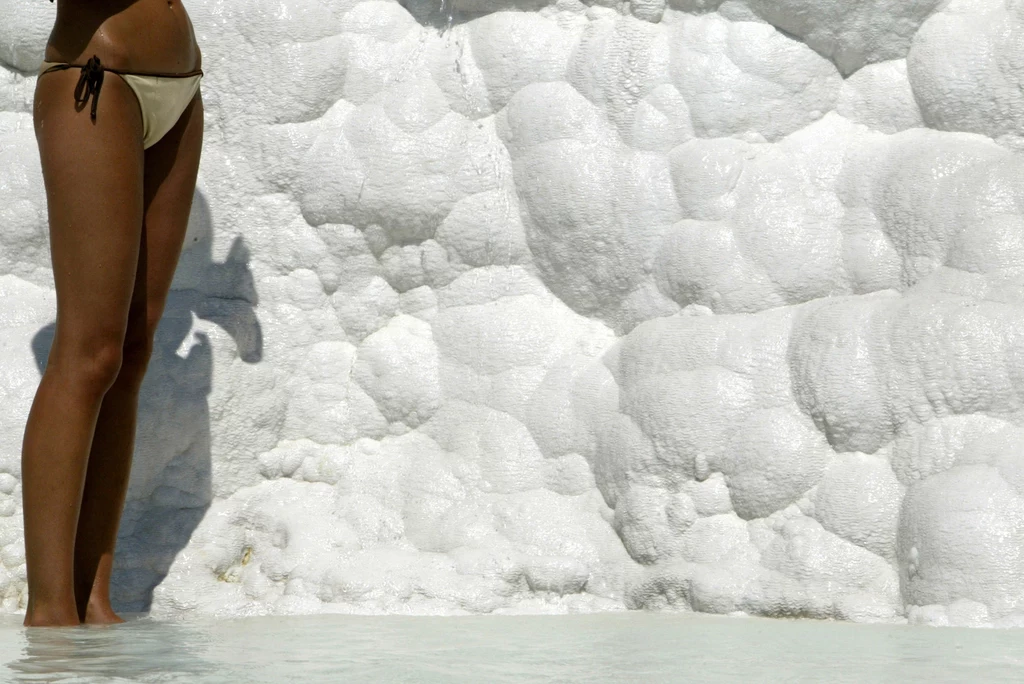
0, 0, 1024, 626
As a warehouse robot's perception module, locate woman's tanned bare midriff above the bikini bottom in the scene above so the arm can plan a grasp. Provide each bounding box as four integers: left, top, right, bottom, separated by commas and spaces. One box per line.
44, 0, 203, 74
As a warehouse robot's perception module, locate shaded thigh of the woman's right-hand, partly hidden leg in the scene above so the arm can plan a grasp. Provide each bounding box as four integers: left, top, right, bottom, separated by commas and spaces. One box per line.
132, 92, 203, 336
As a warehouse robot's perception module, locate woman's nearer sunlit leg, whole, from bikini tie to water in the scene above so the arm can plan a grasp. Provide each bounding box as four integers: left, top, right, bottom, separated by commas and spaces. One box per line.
22, 69, 144, 625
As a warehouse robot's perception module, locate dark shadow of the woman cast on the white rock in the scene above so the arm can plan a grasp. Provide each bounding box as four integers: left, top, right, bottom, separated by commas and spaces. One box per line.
32, 191, 263, 612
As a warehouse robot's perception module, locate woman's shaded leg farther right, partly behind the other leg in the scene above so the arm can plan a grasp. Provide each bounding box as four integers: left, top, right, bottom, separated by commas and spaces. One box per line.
75, 94, 203, 624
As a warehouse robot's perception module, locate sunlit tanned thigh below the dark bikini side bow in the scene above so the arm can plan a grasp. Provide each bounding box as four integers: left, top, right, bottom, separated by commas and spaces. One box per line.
33, 69, 143, 356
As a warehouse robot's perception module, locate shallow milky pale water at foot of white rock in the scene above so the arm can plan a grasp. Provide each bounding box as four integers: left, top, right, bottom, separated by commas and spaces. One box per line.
0, 612, 1024, 684
